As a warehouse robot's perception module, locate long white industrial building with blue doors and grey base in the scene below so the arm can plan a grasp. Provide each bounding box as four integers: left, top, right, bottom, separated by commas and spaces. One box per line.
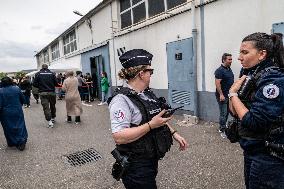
36, 0, 284, 121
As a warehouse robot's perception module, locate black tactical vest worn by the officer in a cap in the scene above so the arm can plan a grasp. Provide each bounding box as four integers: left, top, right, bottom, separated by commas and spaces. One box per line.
108, 87, 173, 159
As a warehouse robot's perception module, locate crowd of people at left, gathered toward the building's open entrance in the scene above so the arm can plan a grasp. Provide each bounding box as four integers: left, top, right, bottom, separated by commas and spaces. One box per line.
0, 64, 109, 148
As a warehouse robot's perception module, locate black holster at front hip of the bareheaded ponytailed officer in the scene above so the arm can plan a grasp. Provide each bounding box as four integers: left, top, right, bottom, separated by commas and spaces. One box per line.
225, 119, 240, 143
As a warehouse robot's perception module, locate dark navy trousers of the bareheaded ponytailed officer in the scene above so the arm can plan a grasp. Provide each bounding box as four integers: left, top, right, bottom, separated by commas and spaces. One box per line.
244, 152, 284, 189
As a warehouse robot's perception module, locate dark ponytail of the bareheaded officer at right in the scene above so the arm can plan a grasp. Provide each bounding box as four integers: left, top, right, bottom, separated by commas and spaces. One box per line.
271, 33, 284, 68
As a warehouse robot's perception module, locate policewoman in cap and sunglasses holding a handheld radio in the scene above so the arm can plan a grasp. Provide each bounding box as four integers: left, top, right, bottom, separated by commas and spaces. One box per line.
108, 49, 187, 189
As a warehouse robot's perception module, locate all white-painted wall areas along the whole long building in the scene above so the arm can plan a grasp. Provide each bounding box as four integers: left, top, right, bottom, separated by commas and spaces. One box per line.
38, 0, 284, 92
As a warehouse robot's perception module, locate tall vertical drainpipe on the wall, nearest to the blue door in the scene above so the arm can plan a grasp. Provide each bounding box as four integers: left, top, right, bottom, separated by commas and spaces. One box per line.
191, 0, 198, 116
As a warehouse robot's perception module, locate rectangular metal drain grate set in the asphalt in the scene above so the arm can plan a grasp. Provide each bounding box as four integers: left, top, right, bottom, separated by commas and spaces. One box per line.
63, 148, 102, 166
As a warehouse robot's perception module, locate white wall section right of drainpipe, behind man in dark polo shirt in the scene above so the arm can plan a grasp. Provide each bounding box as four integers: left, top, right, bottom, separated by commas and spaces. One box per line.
203, 0, 284, 91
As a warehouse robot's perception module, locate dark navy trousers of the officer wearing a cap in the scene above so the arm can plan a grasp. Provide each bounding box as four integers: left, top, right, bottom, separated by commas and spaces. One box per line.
122, 159, 158, 189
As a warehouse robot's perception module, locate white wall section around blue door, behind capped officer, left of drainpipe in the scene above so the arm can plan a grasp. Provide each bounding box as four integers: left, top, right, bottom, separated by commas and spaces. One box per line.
115, 13, 191, 89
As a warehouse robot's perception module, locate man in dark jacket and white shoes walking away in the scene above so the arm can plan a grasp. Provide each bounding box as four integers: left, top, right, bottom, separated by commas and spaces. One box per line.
33, 64, 57, 128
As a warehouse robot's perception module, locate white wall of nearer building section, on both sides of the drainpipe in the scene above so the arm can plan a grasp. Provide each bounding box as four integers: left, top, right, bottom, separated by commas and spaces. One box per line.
111, 0, 284, 92
